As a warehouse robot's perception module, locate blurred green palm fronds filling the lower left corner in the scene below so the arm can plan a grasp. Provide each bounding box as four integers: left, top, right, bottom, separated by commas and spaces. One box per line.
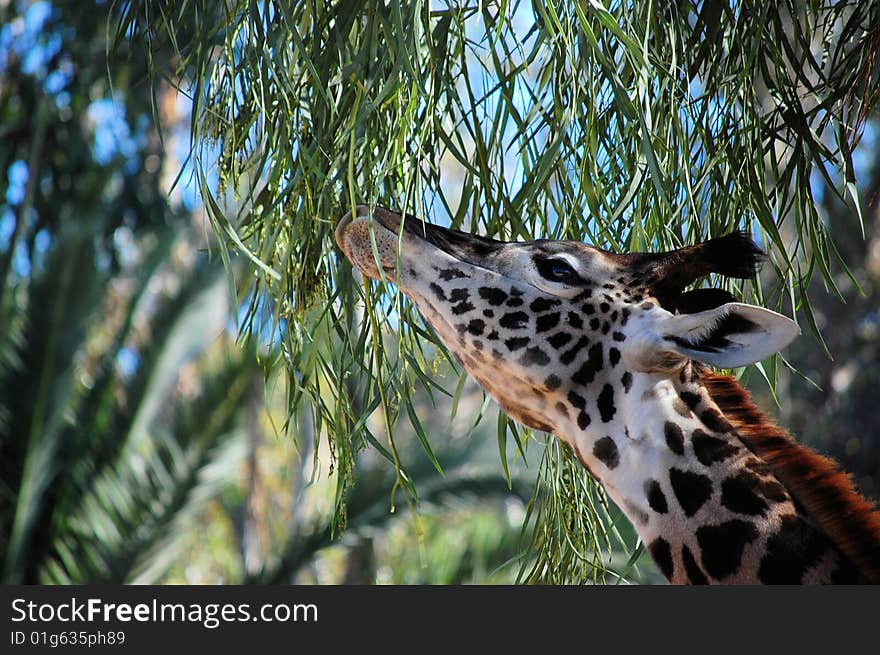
0, 213, 255, 583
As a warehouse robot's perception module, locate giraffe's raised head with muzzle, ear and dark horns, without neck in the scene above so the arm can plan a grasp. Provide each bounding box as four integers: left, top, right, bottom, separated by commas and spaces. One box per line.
336, 206, 799, 434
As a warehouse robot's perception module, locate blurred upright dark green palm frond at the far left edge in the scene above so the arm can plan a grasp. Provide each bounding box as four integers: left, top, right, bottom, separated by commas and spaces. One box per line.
0, 225, 107, 581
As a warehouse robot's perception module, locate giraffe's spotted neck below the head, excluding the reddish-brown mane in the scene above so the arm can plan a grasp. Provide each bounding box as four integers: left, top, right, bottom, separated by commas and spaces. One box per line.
560, 366, 858, 584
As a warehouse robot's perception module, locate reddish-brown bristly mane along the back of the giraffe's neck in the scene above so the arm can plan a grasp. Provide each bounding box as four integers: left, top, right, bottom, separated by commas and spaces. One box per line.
700, 370, 880, 584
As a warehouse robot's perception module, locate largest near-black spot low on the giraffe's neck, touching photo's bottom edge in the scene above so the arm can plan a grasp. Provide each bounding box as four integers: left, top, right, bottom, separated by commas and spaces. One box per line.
758, 515, 830, 584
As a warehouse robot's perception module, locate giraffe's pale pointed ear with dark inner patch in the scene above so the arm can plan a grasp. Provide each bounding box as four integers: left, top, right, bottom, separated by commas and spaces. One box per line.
657, 302, 801, 368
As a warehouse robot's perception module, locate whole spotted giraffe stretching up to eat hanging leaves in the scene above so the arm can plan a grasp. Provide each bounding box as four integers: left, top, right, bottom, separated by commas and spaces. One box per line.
336, 206, 880, 584
